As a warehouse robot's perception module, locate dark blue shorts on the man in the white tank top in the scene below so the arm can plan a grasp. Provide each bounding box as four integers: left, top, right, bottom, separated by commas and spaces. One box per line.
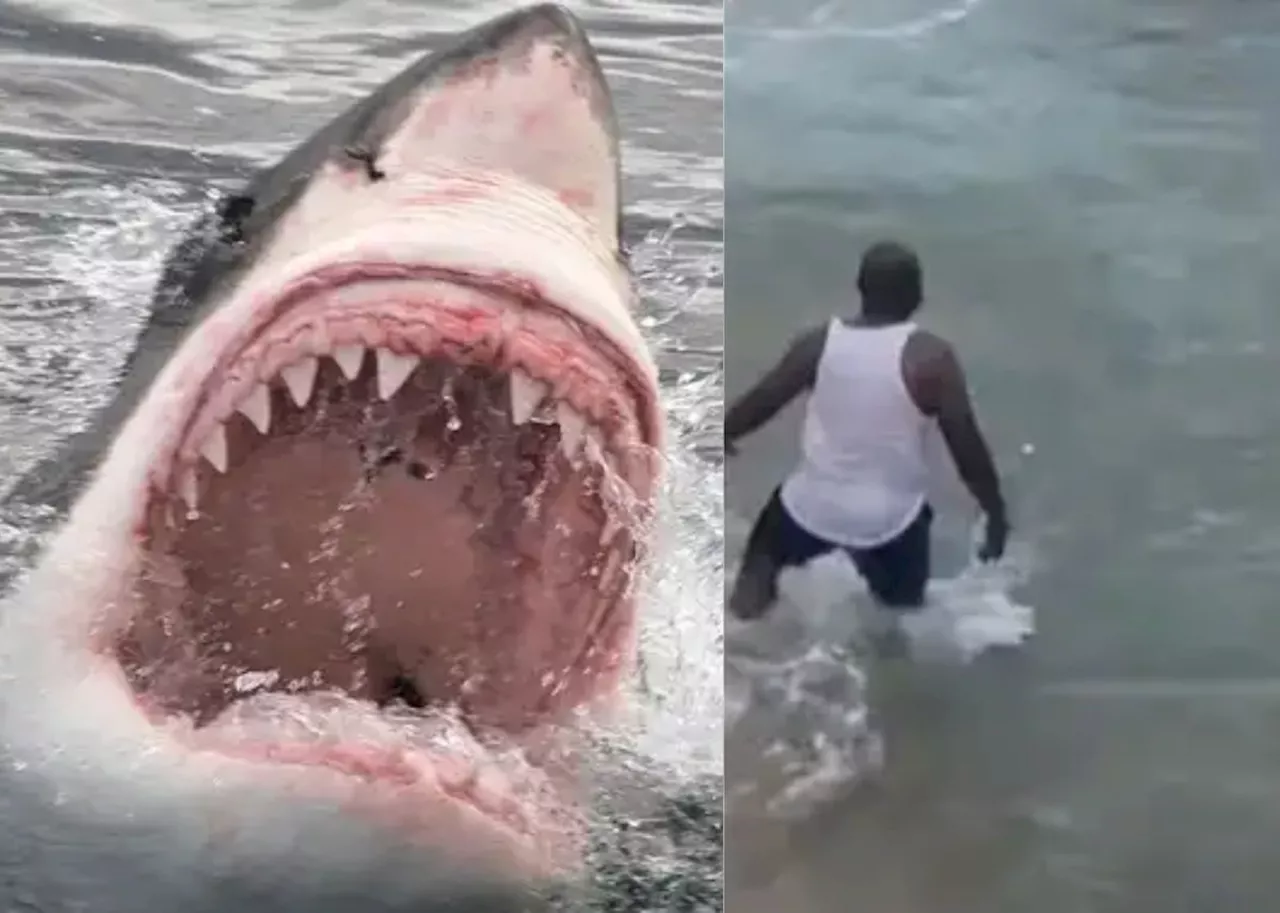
730, 489, 933, 618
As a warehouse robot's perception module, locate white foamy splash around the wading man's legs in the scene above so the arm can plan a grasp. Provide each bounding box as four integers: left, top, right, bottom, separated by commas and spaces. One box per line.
726, 519, 1034, 818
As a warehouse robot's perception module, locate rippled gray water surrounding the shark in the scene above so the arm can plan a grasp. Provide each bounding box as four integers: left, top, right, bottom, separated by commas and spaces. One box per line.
0, 0, 723, 913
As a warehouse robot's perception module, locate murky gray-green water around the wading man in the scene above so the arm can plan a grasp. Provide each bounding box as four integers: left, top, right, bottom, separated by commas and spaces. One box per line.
726, 0, 1280, 913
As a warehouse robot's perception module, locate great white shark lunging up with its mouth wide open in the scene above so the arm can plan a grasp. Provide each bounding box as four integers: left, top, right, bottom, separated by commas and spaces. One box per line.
0, 5, 663, 896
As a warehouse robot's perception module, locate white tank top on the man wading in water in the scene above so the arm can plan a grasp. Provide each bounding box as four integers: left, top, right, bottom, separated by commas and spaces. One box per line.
781, 319, 933, 548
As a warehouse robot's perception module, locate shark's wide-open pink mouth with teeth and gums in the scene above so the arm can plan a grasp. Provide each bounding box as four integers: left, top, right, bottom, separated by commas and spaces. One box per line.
103, 264, 653, 870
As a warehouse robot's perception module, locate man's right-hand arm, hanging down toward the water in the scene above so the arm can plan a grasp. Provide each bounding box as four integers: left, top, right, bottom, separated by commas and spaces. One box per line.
913, 333, 1007, 525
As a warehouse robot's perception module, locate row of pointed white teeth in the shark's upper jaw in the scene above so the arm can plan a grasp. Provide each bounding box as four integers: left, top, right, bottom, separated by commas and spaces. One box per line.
179, 344, 614, 491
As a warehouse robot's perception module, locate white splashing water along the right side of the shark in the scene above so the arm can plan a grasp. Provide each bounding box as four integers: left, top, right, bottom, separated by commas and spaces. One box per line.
584, 203, 724, 913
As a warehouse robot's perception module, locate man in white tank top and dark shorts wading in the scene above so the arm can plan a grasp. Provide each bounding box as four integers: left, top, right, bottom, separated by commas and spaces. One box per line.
724, 242, 1009, 618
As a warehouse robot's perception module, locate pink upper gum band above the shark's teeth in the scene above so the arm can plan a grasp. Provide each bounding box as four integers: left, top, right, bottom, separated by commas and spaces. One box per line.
152, 263, 659, 501
